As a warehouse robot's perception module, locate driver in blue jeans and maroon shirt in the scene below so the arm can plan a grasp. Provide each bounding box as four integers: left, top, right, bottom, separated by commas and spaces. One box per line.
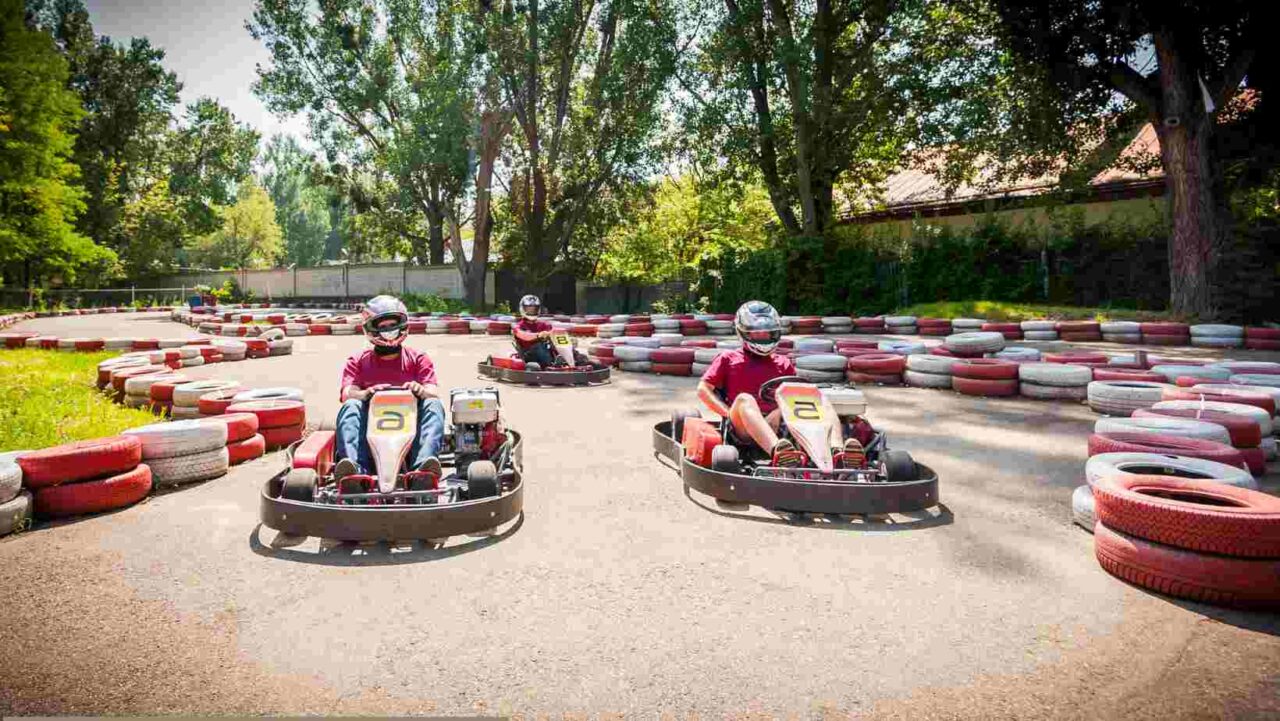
334, 296, 444, 482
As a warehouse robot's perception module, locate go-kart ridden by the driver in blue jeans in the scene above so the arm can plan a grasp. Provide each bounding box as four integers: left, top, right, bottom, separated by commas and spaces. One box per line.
260, 388, 525, 542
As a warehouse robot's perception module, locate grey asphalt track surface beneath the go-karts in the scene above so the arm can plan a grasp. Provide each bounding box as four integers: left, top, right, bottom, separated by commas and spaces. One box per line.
0, 314, 1280, 720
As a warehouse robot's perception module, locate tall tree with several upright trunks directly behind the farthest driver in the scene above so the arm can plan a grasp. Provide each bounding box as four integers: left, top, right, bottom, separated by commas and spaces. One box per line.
484, 0, 677, 284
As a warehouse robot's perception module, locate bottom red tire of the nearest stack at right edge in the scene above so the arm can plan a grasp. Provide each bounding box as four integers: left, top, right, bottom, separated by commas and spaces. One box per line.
1093, 523, 1280, 608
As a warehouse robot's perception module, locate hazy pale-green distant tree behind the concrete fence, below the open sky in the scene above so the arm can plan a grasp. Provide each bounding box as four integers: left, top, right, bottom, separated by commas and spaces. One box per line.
261, 136, 332, 265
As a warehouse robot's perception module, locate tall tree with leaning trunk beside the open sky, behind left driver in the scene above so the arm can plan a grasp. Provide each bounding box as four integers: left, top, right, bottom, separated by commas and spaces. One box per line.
248, 0, 502, 307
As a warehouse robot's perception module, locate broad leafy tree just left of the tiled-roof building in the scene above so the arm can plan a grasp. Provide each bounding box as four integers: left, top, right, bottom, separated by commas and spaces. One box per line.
677, 0, 1000, 236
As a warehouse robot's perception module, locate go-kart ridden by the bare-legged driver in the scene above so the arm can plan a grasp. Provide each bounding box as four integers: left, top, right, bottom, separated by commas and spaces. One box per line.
653, 377, 938, 515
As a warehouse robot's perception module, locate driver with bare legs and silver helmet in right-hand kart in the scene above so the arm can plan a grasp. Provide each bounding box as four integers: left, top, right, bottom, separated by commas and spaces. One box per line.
698, 301, 867, 467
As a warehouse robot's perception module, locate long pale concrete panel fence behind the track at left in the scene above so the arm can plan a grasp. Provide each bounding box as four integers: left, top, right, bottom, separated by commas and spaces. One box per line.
155, 263, 494, 304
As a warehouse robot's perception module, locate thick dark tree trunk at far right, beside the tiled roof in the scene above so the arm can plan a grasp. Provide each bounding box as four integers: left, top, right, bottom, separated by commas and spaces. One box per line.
1155, 32, 1224, 319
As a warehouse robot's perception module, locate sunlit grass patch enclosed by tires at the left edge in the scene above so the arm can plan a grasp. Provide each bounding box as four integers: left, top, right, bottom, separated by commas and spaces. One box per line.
0, 348, 156, 451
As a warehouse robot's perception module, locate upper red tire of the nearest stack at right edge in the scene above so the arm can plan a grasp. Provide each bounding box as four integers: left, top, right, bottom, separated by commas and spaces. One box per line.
1093, 474, 1280, 558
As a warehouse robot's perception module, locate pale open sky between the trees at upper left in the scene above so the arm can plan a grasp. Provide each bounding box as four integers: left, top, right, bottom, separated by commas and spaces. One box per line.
84, 0, 306, 140
